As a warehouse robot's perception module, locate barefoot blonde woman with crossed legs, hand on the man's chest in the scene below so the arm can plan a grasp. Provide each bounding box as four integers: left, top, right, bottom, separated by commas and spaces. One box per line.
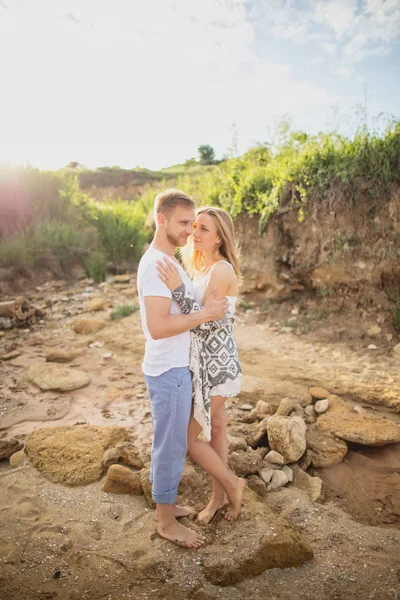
159, 207, 245, 523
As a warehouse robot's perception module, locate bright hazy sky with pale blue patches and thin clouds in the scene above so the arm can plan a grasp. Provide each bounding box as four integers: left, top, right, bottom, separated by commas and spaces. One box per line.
0, 0, 400, 169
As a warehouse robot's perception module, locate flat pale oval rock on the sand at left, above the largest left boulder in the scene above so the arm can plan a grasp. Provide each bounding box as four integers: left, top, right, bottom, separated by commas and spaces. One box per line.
25, 363, 90, 392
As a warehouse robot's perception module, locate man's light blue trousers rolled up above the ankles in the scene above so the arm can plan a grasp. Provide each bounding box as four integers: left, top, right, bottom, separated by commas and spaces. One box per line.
145, 367, 192, 504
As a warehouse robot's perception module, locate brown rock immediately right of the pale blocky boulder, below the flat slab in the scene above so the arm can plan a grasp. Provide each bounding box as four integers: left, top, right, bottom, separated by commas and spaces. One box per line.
306, 423, 347, 467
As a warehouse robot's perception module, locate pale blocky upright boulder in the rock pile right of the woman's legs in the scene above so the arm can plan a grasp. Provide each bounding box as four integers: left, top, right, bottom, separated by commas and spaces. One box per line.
267, 415, 306, 463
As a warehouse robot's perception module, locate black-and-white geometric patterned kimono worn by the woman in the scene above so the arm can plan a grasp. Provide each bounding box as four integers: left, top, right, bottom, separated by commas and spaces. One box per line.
172, 283, 242, 440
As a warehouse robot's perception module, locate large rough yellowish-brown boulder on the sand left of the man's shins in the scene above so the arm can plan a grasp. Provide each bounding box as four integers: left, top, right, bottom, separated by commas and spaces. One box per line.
25, 425, 128, 485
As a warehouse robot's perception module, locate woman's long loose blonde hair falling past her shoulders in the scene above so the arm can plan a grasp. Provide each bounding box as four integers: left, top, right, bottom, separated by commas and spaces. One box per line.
182, 206, 242, 286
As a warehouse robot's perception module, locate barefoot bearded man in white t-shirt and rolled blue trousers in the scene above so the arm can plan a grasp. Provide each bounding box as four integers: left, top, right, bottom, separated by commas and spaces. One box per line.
137, 189, 227, 548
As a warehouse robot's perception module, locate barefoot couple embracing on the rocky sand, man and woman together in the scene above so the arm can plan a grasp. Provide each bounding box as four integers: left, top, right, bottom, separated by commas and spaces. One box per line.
137, 190, 245, 548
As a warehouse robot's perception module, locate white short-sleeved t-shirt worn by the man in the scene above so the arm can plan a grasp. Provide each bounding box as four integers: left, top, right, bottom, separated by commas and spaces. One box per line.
137, 246, 194, 376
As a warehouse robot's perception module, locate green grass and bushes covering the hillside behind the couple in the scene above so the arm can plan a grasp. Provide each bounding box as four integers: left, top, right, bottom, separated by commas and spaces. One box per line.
0, 122, 400, 280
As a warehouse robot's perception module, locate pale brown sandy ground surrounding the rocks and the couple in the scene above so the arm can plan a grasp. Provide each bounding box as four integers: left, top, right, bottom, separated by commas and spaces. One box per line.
0, 283, 400, 600
